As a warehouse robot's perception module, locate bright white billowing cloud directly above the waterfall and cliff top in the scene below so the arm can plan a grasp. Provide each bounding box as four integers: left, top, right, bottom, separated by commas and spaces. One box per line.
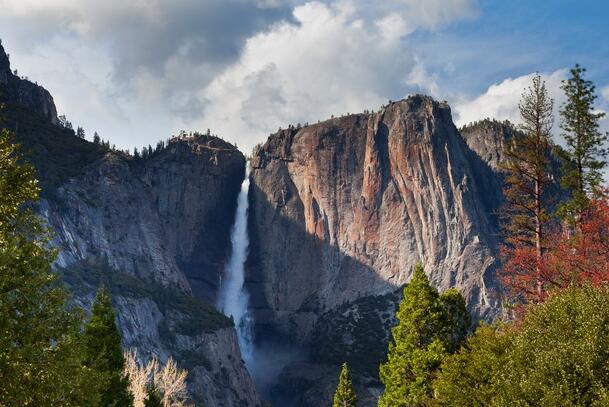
194, 2, 452, 151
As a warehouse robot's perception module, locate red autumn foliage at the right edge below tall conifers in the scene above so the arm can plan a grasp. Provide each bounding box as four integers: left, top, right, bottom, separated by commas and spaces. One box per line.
500, 196, 609, 302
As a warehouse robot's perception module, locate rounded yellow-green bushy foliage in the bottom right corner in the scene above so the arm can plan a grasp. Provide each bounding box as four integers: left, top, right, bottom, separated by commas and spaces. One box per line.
434, 286, 609, 406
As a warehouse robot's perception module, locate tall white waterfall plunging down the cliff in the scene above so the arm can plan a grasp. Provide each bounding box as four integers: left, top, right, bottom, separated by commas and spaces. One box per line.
218, 166, 254, 367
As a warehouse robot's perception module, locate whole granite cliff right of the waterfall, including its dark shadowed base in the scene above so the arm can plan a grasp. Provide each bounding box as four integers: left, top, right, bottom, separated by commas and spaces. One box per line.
246, 96, 516, 406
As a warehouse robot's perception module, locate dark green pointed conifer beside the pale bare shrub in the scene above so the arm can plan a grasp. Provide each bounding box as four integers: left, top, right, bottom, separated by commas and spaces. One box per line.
83, 287, 133, 407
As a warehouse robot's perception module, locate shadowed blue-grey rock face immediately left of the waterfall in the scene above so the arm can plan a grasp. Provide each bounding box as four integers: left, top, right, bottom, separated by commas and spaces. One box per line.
43, 135, 245, 303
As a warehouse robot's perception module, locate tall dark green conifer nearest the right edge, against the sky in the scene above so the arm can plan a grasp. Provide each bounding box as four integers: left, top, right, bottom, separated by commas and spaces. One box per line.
559, 65, 607, 223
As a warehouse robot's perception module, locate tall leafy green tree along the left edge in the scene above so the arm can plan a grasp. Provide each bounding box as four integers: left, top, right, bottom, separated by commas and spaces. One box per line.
0, 130, 96, 406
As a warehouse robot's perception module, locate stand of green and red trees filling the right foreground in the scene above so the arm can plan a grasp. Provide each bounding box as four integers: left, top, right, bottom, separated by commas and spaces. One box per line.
333, 65, 609, 407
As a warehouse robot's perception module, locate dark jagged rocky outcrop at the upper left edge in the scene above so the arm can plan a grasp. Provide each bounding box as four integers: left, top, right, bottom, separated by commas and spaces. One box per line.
0, 43, 58, 124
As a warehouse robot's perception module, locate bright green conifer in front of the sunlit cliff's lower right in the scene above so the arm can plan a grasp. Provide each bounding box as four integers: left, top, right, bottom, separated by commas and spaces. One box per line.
379, 264, 470, 407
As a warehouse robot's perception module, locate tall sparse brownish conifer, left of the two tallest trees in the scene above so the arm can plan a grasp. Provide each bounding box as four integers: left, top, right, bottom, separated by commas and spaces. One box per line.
502, 74, 554, 289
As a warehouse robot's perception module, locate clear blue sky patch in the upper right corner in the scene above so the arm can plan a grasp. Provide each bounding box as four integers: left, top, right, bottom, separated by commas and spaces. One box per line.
428, 0, 609, 93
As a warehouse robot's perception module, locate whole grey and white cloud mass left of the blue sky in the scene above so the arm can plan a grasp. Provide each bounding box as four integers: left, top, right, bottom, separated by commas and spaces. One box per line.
0, 0, 477, 152
